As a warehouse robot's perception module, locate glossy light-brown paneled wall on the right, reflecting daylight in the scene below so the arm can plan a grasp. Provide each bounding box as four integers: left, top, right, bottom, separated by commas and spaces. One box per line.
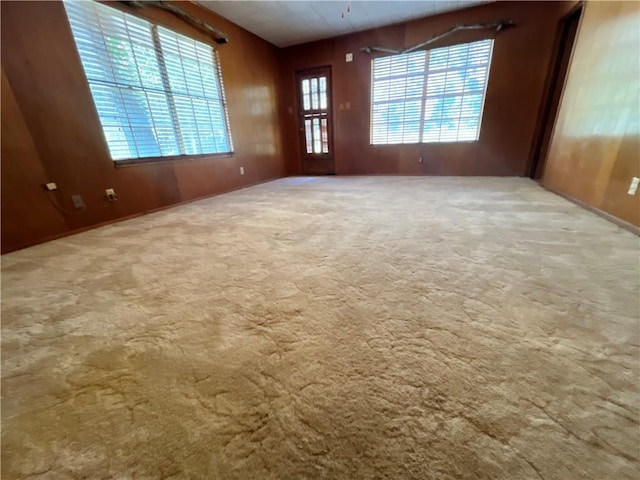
543, 1, 640, 226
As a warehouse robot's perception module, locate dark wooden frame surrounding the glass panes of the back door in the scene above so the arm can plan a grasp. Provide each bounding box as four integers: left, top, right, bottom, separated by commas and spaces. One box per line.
293, 64, 336, 175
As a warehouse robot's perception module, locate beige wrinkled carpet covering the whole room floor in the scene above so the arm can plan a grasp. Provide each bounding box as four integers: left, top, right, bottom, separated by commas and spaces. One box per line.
2, 177, 640, 480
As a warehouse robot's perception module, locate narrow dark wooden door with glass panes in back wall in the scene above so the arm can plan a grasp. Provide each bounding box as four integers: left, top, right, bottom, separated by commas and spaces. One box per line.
296, 67, 335, 175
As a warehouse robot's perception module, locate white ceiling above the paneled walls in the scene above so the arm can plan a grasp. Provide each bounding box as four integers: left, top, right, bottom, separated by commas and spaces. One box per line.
197, 0, 482, 47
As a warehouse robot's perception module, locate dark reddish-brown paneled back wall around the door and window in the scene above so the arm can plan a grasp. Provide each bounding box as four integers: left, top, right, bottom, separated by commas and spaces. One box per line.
282, 2, 575, 175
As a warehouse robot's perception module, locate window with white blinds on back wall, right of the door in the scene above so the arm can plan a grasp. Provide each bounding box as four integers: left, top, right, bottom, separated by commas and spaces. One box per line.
371, 40, 493, 145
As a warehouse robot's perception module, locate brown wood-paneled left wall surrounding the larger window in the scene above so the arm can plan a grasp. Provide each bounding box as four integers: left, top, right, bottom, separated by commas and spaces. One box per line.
0, 1, 285, 252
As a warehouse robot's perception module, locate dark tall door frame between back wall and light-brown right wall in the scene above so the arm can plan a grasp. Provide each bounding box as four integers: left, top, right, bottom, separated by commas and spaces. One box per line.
526, 1, 584, 180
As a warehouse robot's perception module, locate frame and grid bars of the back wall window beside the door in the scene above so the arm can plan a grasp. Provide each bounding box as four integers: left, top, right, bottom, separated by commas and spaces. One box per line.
369, 37, 495, 148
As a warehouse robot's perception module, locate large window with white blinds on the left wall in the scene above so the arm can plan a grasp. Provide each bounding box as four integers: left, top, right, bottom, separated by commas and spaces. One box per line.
65, 0, 232, 161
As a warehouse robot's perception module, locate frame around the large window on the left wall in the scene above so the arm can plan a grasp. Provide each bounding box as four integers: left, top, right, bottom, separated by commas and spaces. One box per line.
65, 0, 231, 168
